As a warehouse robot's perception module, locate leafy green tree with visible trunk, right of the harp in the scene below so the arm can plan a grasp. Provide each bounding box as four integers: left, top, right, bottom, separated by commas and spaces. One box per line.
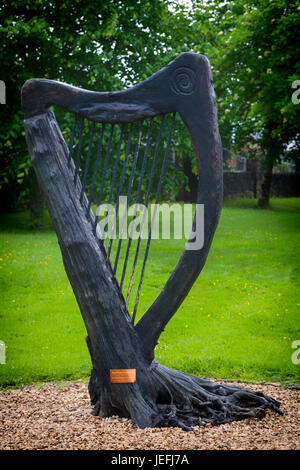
199, 0, 300, 207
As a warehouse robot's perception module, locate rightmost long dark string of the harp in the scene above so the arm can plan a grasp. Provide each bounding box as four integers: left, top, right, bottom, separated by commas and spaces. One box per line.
132, 113, 176, 324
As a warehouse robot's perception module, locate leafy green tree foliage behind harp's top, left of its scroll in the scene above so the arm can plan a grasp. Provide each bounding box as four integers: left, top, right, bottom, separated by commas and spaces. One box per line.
0, 0, 186, 217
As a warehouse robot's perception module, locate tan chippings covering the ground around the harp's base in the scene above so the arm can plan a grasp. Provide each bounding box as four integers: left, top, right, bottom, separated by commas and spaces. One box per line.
0, 382, 300, 450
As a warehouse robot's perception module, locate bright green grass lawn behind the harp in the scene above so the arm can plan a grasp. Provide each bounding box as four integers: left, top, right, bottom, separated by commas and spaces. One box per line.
0, 199, 300, 386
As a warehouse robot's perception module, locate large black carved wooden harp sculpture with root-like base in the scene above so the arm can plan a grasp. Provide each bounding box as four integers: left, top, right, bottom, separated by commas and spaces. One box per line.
22, 53, 281, 430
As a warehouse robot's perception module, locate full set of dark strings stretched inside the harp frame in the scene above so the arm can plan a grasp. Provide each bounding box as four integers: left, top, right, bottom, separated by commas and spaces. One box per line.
65, 113, 176, 322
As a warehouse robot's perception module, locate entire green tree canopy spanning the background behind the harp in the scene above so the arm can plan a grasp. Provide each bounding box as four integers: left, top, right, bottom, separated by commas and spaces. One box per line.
0, 0, 300, 210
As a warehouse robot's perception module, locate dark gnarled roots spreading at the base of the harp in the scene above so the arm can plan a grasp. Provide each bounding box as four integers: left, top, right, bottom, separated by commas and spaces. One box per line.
89, 361, 283, 431
